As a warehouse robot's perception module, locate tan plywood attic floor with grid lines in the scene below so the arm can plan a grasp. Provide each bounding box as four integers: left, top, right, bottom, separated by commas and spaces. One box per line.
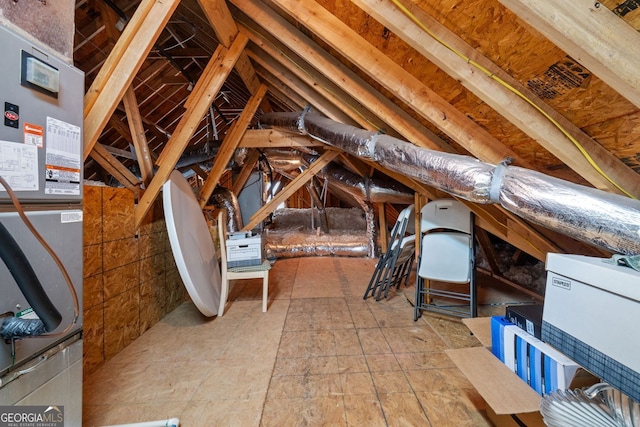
83, 257, 530, 427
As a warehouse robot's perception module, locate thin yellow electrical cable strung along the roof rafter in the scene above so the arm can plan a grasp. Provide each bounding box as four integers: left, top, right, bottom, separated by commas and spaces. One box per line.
391, 0, 636, 199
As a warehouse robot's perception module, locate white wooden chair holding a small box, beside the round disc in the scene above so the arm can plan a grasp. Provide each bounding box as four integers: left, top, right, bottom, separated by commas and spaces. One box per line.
218, 210, 271, 317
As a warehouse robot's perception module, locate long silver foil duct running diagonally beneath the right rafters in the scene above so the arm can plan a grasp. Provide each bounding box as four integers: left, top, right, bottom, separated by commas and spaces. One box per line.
260, 112, 640, 255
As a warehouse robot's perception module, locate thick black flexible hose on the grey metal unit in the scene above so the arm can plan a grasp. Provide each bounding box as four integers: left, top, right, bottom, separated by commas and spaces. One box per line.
0, 222, 62, 332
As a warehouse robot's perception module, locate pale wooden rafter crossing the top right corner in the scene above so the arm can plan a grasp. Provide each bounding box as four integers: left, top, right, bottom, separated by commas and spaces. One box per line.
499, 0, 640, 107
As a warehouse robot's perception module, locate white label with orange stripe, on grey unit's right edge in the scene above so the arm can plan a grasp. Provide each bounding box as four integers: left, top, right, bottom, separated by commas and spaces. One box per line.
44, 117, 82, 195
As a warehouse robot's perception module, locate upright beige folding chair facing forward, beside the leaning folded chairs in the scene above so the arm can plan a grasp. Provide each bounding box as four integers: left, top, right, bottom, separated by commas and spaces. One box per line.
413, 199, 478, 320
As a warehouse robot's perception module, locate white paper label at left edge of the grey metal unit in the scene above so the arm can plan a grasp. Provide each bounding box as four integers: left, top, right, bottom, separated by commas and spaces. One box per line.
0, 141, 38, 191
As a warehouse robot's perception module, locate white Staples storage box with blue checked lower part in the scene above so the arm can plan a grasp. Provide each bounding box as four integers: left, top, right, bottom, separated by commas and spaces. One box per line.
542, 254, 640, 400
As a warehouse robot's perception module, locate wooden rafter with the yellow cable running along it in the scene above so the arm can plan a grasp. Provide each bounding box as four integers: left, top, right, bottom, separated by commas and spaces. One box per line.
360, 0, 640, 198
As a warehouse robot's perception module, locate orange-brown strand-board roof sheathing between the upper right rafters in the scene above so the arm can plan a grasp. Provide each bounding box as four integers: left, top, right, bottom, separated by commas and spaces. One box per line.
314, 0, 639, 184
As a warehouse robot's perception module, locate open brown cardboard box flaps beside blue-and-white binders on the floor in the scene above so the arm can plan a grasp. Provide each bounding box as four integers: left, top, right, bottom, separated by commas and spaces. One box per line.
446, 317, 599, 427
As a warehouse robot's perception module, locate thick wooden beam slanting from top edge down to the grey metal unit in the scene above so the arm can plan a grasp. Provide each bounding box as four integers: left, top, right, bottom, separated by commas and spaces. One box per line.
84, 0, 180, 159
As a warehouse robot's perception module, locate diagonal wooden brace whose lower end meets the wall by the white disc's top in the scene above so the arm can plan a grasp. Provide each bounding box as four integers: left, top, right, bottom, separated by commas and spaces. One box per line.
135, 35, 247, 228
